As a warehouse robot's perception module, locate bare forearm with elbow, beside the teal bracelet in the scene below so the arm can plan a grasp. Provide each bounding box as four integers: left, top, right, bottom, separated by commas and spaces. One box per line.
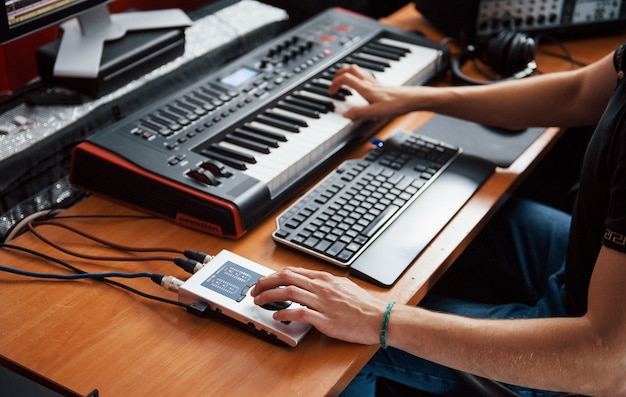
387, 306, 624, 395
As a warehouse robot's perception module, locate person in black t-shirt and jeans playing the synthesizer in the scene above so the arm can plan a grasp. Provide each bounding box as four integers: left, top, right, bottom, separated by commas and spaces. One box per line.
252, 43, 626, 396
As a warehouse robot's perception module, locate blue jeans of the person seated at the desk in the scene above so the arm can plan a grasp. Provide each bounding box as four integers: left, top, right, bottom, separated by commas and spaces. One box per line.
342, 199, 570, 397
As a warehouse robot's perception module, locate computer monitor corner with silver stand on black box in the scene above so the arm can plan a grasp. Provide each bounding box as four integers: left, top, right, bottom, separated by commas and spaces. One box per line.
0, 0, 191, 94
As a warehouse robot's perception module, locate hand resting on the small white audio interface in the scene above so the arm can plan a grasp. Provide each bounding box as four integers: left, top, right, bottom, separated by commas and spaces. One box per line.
251, 267, 386, 345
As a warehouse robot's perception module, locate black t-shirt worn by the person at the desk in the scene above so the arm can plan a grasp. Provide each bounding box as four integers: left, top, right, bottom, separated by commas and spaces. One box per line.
565, 43, 626, 315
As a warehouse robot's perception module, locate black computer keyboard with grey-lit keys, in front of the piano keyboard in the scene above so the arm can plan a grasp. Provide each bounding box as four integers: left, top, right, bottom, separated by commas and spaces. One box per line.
272, 131, 462, 267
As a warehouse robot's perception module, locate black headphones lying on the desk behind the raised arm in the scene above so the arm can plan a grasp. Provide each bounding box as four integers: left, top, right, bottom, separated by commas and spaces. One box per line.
451, 30, 536, 85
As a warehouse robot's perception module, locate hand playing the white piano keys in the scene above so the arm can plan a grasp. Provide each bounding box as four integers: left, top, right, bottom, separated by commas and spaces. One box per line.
328, 65, 414, 120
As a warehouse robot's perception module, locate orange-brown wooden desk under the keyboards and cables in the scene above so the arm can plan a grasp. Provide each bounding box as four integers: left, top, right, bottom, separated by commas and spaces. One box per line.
0, 5, 623, 397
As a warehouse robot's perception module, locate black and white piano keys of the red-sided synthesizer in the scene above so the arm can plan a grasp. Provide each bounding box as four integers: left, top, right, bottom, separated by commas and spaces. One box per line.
194, 38, 437, 195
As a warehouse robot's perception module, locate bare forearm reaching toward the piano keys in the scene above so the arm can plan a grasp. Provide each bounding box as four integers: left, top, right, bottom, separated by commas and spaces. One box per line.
372, 52, 615, 129
